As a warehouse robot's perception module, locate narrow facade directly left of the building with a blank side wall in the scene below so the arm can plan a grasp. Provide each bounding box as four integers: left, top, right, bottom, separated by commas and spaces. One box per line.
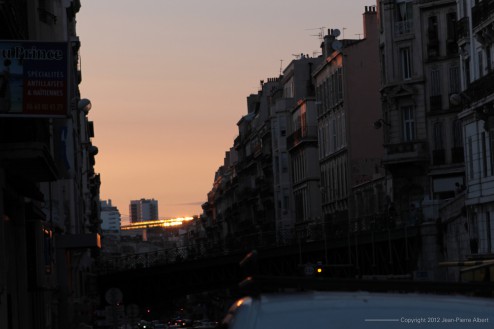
278, 54, 322, 240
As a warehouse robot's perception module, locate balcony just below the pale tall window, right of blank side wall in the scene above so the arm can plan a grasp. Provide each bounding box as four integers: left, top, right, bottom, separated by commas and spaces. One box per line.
383, 141, 428, 165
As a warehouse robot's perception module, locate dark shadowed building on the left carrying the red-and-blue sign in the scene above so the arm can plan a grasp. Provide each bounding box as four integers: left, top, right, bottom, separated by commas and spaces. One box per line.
0, 0, 100, 329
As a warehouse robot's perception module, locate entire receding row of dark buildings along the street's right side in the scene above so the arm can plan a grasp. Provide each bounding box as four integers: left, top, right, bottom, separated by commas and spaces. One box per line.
201, 1, 494, 280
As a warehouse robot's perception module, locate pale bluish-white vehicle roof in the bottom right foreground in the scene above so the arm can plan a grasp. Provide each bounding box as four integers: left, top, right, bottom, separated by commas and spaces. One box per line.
221, 291, 494, 329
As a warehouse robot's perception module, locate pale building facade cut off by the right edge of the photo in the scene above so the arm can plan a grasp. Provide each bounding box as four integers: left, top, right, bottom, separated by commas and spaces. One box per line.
445, 0, 494, 280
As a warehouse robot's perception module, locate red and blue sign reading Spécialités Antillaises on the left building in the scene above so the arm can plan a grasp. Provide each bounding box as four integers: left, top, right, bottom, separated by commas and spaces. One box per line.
0, 40, 69, 117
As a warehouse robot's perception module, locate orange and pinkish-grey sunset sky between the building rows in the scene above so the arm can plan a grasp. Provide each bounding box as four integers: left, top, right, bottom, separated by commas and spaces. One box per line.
77, 0, 376, 220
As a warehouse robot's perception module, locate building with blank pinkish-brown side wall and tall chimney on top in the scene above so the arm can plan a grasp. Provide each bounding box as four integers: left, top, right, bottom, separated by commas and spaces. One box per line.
313, 6, 383, 234
